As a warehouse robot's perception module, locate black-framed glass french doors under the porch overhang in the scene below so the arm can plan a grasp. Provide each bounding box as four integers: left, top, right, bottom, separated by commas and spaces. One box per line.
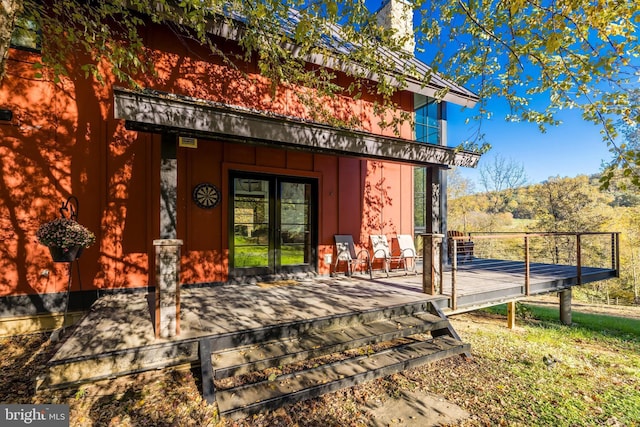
230, 173, 318, 276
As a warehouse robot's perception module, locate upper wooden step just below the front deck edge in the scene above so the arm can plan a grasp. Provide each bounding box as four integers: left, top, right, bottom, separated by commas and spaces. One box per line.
212, 313, 449, 379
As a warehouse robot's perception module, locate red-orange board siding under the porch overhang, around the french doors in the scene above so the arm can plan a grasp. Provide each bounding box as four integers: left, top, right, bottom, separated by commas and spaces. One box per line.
178, 145, 413, 283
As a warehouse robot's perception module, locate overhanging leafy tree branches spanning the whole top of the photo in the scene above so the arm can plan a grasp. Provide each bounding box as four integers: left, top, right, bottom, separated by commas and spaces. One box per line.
0, 0, 640, 171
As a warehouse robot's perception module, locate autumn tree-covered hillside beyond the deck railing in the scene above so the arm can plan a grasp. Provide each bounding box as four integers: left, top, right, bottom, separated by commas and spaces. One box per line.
448, 168, 640, 304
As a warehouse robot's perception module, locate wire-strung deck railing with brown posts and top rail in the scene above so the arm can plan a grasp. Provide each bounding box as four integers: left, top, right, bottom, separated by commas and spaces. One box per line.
421, 232, 620, 310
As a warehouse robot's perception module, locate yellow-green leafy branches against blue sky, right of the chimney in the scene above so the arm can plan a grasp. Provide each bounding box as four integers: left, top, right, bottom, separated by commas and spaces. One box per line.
420, 0, 640, 177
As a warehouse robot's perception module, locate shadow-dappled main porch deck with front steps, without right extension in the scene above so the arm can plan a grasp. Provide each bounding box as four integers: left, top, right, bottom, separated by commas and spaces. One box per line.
38, 277, 470, 417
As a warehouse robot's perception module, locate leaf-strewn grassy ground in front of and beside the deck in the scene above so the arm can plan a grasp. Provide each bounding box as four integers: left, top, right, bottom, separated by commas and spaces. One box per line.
0, 306, 640, 427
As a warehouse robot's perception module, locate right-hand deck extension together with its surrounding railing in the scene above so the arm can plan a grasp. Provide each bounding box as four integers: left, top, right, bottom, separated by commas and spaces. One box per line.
436, 232, 620, 314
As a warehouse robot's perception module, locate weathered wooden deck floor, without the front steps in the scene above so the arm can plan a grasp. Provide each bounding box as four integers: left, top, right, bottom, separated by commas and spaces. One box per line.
43, 259, 616, 380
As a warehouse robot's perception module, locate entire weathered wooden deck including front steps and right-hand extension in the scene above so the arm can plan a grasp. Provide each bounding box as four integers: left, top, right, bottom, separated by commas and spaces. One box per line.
38, 259, 616, 415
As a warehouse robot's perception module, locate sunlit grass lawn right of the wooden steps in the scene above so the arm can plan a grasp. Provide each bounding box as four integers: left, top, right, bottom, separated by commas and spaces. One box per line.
430, 306, 640, 426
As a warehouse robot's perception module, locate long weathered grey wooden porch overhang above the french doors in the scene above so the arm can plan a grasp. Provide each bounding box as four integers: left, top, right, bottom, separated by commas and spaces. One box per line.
114, 88, 480, 167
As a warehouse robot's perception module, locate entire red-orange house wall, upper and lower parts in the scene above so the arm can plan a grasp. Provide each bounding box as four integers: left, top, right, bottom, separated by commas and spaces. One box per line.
0, 22, 413, 304
